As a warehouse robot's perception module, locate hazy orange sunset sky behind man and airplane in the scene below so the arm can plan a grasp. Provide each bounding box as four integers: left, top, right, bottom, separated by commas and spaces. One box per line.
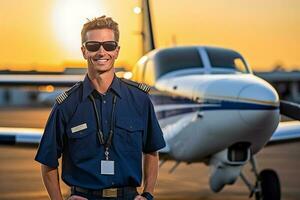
0, 0, 300, 70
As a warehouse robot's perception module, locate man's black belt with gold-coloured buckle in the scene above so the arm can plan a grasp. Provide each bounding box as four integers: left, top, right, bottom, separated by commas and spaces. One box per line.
71, 186, 137, 197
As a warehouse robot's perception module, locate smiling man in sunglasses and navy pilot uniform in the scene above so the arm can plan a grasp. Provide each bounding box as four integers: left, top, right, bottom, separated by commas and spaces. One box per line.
35, 16, 165, 200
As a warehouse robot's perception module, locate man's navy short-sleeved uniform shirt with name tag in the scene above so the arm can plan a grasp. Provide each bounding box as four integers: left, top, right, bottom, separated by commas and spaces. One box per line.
35, 76, 165, 189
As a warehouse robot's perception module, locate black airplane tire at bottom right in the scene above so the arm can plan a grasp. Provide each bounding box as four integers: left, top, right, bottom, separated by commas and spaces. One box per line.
255, 169, 281, 200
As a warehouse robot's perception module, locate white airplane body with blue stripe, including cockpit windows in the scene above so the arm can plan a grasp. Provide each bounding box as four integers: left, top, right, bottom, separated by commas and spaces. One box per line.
133, 46, 280, 165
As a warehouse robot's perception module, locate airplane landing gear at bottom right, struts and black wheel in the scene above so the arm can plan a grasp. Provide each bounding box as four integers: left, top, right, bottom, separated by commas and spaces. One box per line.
240, 155, 281, 200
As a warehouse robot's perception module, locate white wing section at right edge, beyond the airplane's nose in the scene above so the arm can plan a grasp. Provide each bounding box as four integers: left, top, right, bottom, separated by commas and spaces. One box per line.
268, 121, 300, 145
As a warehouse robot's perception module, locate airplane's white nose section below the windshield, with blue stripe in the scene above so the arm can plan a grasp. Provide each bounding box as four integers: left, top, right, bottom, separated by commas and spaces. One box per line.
151, 74, 280, 162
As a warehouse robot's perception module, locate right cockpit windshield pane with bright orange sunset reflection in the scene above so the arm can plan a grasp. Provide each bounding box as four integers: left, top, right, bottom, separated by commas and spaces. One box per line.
206, 48, 249, 73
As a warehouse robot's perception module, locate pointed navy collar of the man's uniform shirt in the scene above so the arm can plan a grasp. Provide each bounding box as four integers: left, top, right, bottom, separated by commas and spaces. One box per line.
82, 75, 122, 100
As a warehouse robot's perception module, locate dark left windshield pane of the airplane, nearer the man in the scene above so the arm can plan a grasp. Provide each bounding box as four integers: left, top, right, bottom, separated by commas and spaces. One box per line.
155, 47, 203, 77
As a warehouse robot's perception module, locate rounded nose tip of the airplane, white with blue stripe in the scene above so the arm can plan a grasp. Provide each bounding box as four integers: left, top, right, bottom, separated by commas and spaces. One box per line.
238, 84, 279, 128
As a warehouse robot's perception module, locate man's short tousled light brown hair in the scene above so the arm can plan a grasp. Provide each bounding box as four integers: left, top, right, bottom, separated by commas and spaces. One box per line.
81, 15, 120, 44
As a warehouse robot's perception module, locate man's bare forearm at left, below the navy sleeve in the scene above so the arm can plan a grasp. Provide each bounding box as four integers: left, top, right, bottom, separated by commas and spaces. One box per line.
41, 164, 63, 200
